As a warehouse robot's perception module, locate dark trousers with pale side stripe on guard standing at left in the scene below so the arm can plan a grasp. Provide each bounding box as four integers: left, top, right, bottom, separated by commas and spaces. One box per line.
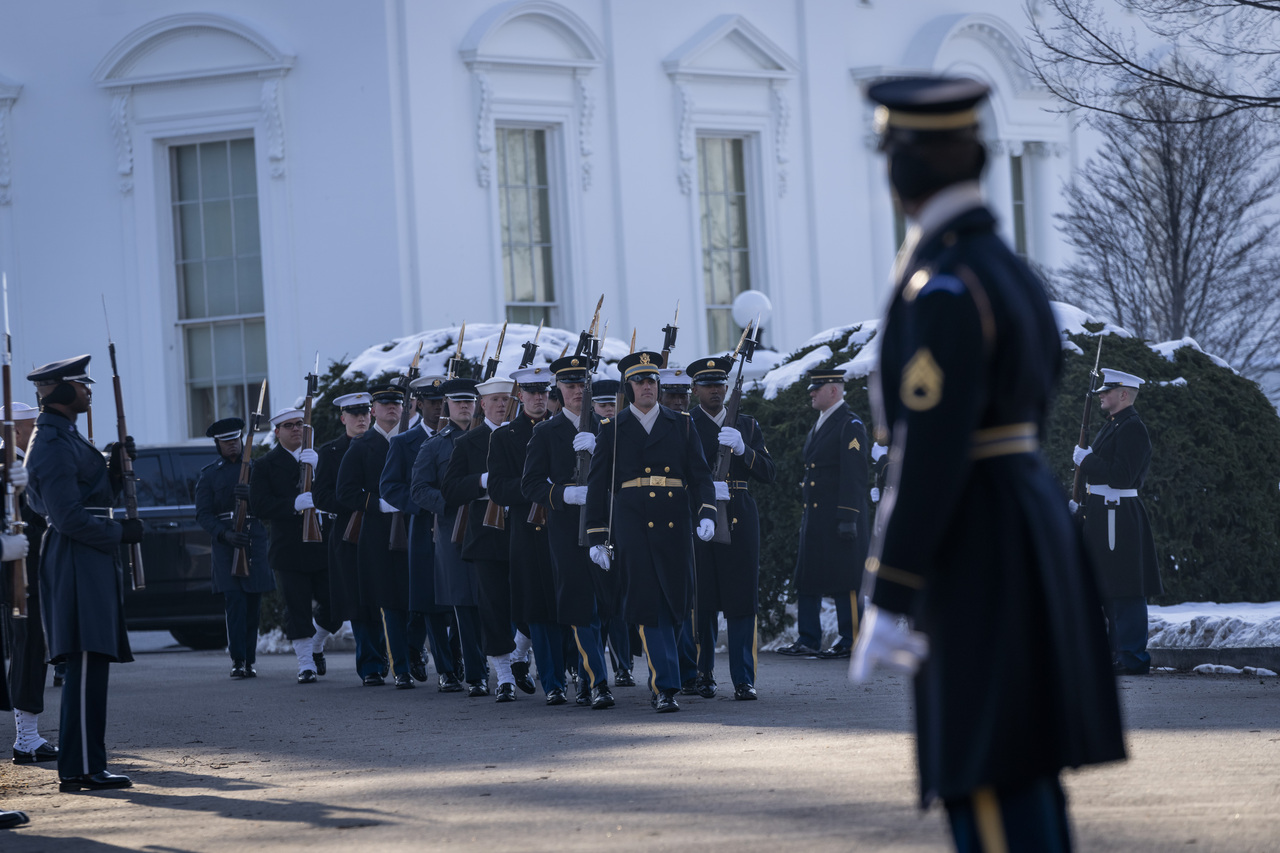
58, 652, 111, 779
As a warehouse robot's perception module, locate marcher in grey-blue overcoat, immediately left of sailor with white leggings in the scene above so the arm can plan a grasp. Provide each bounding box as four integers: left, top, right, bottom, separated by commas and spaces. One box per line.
410, 378, 489, 697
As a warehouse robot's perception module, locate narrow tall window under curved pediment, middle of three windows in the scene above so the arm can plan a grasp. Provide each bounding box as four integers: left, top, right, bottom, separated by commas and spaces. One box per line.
497, 127, 556, 325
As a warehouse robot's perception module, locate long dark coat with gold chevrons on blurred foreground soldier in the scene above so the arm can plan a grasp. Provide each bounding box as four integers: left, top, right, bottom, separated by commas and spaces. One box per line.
868, 206, 1124, 803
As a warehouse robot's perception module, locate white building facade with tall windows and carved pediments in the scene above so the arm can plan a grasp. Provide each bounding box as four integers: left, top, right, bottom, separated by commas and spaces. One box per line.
0, 0, 1083, 443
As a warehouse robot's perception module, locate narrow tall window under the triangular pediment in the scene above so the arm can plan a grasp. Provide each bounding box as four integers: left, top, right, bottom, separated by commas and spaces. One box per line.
698, 136, 751, 351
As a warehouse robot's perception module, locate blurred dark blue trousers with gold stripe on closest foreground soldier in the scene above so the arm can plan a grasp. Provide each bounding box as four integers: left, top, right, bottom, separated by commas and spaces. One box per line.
946, 776, 1071, 853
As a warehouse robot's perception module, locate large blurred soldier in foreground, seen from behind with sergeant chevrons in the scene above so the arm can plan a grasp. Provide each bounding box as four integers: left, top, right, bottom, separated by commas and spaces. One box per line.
850, 78, 1124, 850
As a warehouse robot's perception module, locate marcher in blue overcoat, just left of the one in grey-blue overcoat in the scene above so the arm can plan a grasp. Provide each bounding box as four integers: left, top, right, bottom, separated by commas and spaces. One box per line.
379, 377, 462, 693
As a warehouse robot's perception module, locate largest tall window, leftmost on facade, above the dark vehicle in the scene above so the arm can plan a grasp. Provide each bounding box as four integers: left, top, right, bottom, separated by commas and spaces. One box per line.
169, 138, 266, 438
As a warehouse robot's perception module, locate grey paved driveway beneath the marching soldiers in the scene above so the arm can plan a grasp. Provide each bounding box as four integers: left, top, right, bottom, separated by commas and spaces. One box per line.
0, 640, 1280, 853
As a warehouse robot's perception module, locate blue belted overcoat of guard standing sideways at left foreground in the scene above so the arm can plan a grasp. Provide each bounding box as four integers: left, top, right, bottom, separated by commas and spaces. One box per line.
27, 411, 133, 663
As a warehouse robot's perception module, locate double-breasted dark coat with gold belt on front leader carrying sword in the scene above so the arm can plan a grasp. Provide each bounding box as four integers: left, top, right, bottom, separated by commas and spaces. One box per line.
586, 406, 716, 625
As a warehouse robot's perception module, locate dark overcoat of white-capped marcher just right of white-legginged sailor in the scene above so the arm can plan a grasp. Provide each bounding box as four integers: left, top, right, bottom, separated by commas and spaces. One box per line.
489, 411, 556, 624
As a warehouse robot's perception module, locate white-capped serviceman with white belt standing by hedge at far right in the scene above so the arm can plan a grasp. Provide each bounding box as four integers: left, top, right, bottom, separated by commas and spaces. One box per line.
1073, 368, 1164, 675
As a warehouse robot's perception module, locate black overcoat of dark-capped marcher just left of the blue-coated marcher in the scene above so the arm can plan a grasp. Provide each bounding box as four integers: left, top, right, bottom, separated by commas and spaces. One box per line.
335, 427, 408, 610
